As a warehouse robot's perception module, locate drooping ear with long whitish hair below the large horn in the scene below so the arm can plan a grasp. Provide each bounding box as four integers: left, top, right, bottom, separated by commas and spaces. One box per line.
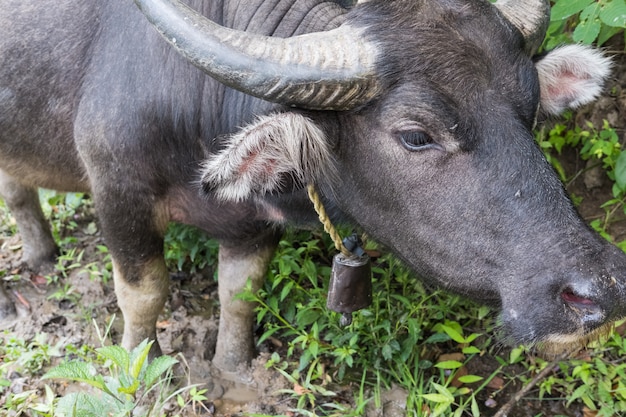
201, 113, 334, 201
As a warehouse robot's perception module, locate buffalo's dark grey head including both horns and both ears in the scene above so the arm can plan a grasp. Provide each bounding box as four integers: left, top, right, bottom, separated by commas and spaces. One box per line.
136, 0, 626, 350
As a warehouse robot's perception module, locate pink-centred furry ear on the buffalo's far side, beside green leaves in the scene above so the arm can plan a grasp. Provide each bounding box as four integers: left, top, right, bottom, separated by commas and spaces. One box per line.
536, 45, 611, 114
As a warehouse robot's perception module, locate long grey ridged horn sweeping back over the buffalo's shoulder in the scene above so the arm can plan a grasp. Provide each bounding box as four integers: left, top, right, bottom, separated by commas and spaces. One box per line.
135, 0, 380, 110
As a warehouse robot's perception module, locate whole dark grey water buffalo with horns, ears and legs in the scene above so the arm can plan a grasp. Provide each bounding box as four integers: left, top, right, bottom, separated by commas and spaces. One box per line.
0, 0, 626, 369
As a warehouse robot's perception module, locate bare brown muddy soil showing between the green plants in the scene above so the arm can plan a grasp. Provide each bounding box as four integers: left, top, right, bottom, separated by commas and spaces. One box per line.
0, 41, 626, 417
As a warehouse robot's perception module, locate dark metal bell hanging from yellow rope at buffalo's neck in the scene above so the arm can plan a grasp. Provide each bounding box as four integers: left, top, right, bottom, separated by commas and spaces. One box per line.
326, 252, 372, 326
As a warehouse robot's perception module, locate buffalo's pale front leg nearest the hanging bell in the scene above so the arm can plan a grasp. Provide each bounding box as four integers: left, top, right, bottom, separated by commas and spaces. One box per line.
213, 236, 276, 371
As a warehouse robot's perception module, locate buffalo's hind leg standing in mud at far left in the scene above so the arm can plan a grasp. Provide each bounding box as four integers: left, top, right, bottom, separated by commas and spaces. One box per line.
0, 170, 57, 320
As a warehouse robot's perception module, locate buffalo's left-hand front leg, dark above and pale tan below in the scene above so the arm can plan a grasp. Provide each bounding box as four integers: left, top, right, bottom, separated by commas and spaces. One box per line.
93, 184, 169, 357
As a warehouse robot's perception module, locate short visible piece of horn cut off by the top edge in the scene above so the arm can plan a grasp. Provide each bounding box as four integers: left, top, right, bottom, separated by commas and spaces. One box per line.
494, 0, 550, 55
